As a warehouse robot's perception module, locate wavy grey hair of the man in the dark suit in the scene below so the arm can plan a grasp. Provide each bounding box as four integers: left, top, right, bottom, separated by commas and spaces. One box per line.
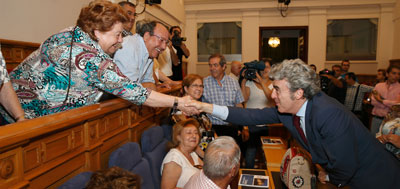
269, 59, 321, 99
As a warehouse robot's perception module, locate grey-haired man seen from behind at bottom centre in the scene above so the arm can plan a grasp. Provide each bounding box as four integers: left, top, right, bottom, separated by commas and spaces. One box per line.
184, 136, 240, 189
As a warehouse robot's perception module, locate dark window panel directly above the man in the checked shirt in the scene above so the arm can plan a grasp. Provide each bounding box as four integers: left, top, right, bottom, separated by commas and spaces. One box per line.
197, 22, 242, 62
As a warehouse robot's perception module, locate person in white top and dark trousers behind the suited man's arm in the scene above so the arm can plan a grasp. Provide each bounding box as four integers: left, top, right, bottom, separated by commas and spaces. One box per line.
241, 59, 275, 168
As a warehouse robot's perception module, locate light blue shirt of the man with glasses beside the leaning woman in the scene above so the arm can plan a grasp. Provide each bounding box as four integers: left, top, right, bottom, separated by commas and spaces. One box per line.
114, 34, 154, 83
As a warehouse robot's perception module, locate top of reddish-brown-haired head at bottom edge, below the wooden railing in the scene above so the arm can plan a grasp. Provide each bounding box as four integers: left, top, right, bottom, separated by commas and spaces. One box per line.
86, 167, 140, 189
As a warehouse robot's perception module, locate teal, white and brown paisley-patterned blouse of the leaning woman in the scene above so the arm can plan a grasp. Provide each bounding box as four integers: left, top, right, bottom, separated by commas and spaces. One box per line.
5, 27, 150, 119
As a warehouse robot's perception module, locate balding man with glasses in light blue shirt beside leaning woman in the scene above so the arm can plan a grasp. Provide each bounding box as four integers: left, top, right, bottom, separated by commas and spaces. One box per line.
114, 20, 170, 89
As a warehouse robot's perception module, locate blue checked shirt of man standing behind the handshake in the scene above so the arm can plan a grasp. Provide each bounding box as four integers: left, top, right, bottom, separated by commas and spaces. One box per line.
202, 75, 244, 125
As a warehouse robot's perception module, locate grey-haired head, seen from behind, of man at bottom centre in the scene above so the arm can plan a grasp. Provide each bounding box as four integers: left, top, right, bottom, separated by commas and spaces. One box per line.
203, 136, 240, 179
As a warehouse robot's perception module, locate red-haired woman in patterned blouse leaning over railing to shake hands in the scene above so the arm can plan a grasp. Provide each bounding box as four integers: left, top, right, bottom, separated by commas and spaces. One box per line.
2, 0, 198, 119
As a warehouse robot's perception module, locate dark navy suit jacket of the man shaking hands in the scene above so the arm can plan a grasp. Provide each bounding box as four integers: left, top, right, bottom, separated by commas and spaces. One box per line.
227, 92, 400, 188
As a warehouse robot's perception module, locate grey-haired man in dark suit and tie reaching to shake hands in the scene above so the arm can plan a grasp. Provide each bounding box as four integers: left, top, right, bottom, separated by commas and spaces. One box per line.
191, 59, 400, 188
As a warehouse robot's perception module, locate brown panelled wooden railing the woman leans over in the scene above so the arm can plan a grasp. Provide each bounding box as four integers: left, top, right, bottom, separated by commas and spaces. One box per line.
0, 87, 180, 188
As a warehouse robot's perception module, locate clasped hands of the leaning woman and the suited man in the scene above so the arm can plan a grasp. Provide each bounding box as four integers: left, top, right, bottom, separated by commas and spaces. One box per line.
178, 96, 213, 116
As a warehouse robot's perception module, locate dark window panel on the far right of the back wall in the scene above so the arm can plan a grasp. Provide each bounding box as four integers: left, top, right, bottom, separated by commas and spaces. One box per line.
326, 18, 378, 60
